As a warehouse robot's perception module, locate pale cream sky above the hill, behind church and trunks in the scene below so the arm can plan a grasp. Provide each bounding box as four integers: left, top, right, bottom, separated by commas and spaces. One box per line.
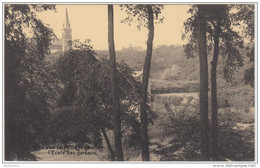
39, 4, 190, 50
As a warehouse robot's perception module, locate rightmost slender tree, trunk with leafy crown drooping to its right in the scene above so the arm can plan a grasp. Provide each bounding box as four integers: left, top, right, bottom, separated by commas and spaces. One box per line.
207, 5, 246, 160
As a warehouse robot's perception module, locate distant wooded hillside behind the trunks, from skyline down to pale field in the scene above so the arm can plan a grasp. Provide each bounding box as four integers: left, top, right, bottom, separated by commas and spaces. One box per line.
96, 45, 254, 107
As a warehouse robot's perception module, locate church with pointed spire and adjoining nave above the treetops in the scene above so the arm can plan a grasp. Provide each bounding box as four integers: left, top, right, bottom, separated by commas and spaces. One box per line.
50, 9, 72, 53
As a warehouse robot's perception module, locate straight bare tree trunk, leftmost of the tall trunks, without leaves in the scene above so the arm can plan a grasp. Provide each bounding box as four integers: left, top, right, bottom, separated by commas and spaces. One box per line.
108, 5, 124, 161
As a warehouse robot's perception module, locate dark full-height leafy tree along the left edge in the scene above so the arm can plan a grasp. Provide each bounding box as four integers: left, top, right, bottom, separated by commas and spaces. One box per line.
4, 4, 55, 160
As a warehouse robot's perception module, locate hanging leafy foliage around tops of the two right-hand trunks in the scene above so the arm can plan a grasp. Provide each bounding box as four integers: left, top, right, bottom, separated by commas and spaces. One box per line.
183, 5, 244, 82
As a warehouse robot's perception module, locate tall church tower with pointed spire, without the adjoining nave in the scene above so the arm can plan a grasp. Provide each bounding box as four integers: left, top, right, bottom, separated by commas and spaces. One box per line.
62, 8, 72, 52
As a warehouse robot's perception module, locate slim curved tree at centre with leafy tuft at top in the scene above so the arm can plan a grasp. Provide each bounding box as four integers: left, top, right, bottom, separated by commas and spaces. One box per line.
122, 5, 163, 161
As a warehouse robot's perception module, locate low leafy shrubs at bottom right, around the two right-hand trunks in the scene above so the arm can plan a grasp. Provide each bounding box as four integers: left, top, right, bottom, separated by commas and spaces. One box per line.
153, 97, 254, 161
